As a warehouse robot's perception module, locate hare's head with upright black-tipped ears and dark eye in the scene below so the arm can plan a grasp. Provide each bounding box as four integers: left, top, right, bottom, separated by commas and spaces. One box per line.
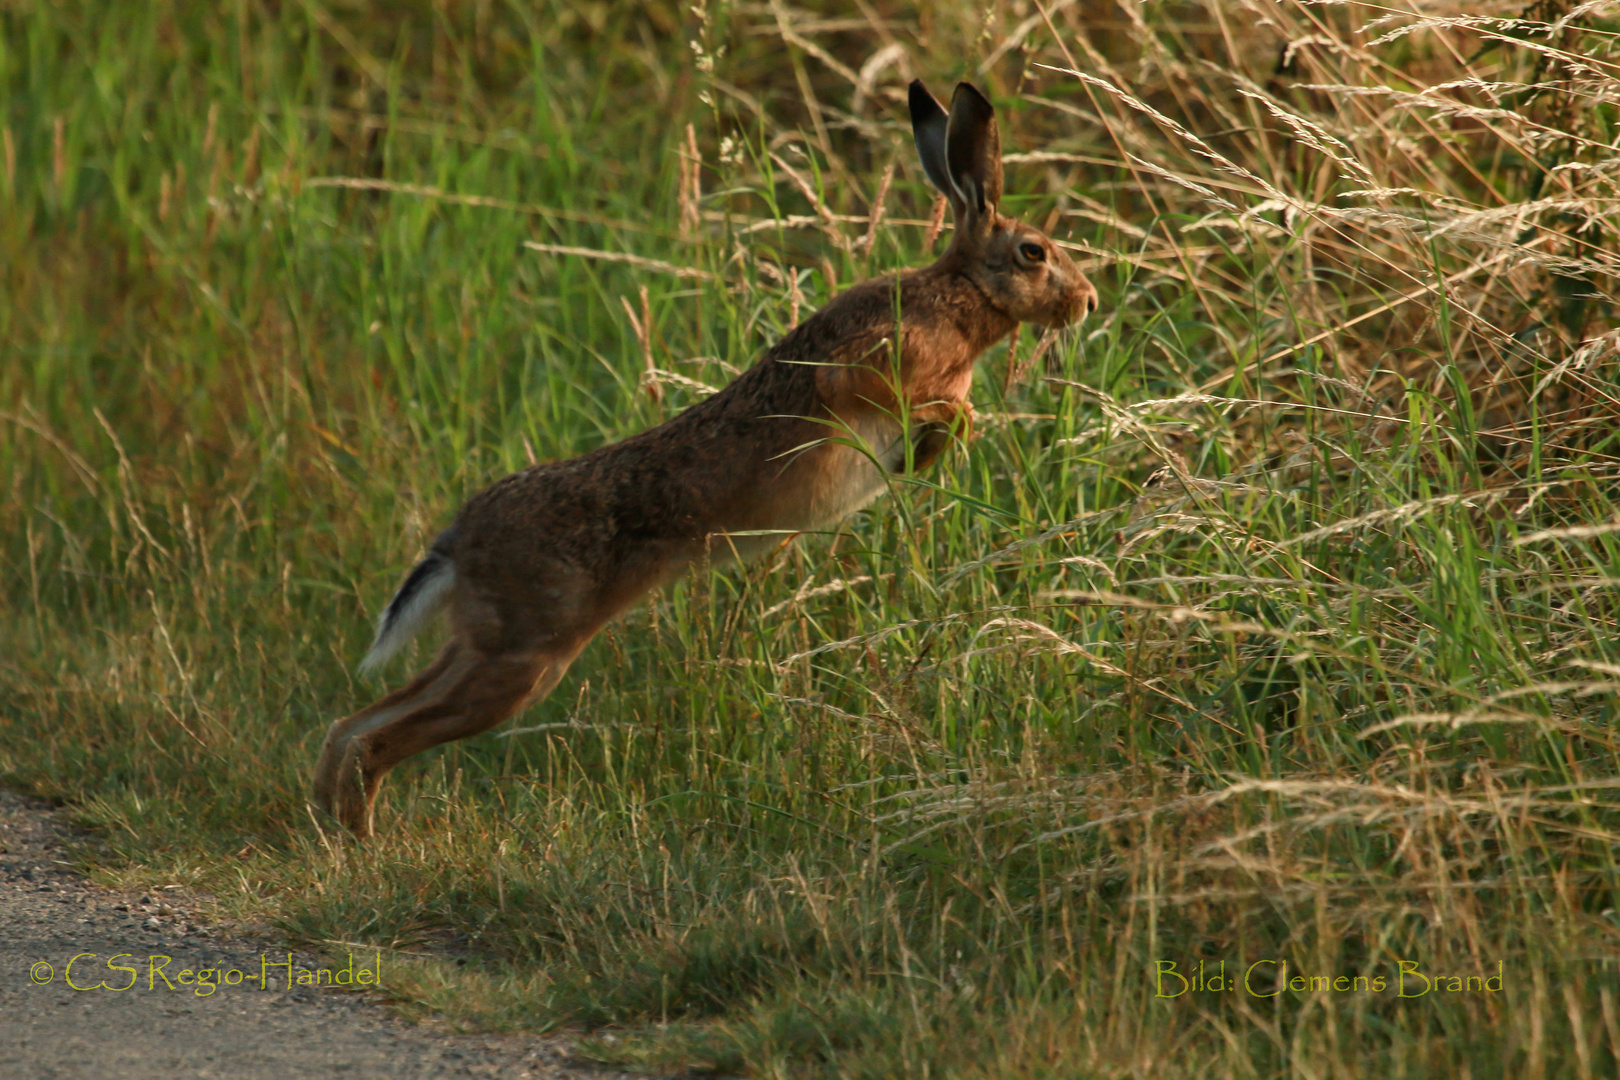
910, 79, 1097, 327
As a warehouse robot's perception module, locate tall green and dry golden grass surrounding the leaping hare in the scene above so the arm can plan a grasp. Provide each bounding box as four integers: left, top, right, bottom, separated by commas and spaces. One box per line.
9, 0, 1620, 1077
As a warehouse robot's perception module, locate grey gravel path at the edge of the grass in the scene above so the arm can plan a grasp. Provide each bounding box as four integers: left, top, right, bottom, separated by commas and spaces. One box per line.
0, 790, 644, 1080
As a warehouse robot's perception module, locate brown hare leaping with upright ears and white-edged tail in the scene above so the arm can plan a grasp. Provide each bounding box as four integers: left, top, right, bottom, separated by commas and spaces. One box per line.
314, 81, 1097, 839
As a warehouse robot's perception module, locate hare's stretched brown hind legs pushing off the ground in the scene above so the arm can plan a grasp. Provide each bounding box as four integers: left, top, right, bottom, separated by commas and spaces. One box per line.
314, 641, 583, 839
